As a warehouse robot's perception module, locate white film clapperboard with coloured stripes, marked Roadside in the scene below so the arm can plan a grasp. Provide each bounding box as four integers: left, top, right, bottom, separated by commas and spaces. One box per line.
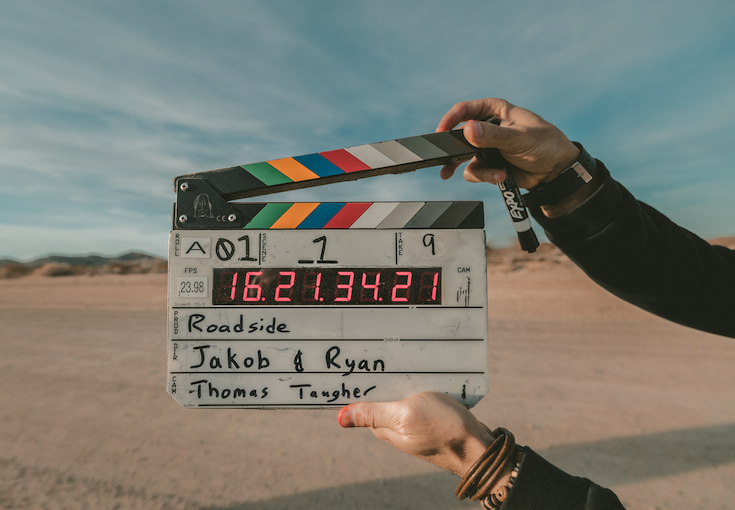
167, 130, 488, 409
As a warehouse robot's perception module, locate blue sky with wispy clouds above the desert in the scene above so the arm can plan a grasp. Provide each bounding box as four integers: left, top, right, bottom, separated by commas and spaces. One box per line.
0, 0, 735, 260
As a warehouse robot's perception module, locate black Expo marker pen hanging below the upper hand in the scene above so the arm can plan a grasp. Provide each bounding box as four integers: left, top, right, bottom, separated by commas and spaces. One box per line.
478, 116, 539, 253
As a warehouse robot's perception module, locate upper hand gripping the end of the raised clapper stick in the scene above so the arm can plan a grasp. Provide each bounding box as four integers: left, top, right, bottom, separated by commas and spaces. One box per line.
436, 98, 580, 189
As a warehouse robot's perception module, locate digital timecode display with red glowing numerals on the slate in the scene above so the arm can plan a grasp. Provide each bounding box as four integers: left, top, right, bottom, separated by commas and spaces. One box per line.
212, 267, 442, 306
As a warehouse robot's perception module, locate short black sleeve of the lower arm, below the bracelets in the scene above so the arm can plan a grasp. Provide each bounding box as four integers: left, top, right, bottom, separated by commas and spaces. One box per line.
501, 447, 624, 510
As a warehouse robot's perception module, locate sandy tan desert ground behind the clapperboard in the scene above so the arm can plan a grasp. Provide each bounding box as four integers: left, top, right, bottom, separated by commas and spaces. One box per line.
0, 260, 735, 510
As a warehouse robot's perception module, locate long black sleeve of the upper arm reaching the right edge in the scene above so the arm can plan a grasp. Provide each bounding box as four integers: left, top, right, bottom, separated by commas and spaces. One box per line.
531, 161, 735, 338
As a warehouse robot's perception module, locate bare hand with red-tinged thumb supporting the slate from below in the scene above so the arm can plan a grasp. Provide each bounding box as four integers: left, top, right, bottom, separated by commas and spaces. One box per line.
337, 392, 494, 476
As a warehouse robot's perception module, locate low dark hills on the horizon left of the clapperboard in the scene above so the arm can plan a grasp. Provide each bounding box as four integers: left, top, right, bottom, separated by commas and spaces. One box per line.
0, 252, 167, 278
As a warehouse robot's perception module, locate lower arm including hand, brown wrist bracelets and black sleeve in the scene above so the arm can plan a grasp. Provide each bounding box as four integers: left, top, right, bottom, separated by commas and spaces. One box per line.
337, 392, 622, 510
